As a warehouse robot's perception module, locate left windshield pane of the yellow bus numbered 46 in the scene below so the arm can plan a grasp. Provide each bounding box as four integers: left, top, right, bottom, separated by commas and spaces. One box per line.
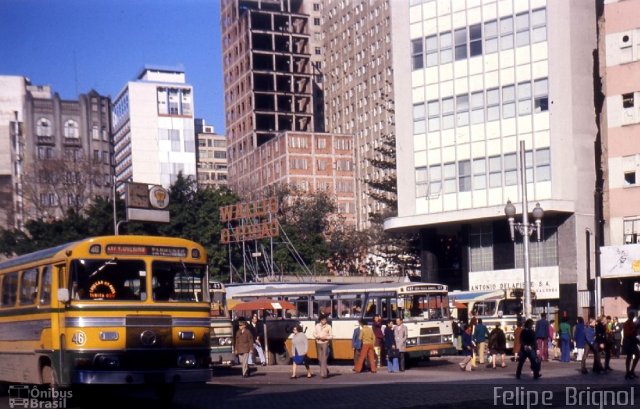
71, 258, 146, 301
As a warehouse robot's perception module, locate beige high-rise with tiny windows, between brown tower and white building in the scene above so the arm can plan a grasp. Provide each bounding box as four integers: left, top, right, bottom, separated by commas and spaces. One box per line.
323, 0, 395, 229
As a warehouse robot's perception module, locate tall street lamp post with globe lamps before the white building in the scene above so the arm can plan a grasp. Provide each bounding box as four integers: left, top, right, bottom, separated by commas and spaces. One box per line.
504, 141, 544, 318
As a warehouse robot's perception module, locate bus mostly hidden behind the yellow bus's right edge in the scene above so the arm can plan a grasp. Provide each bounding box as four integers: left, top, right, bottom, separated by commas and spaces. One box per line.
209, 281, 236, 365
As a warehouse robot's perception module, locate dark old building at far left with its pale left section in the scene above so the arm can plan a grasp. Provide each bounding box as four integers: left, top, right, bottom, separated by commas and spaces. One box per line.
0, 77, 112, 228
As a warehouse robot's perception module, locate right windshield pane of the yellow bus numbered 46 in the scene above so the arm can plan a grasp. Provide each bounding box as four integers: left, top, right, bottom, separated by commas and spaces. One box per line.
151, 261, 208, 302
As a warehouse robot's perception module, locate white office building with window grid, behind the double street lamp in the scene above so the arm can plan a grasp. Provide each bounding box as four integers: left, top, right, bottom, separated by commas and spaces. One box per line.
385, 0, 596, 316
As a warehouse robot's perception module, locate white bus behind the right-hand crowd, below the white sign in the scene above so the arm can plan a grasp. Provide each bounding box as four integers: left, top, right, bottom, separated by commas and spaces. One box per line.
449, 289, 535, 349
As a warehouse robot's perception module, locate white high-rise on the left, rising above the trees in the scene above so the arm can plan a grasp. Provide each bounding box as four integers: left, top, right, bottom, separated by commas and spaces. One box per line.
112, 66, 196, 192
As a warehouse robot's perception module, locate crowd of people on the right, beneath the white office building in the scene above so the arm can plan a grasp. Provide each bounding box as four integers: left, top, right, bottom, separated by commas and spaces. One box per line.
454, 311, 640, 379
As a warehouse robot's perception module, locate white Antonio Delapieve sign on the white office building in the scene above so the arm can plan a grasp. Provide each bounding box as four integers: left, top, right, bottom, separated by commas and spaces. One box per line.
469, 266, 560, 300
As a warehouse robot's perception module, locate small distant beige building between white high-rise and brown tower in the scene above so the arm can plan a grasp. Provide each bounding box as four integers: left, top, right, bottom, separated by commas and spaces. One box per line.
195, 118, 228, 188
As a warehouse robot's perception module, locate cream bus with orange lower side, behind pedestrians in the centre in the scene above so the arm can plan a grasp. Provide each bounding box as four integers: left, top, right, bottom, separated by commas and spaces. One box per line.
226, 283, 455, 360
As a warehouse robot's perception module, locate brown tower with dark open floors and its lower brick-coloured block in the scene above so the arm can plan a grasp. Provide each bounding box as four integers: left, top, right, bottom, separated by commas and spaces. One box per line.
221, 0, 355, 223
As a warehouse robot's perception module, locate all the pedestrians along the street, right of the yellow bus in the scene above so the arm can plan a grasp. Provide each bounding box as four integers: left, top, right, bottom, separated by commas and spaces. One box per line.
234, 312, 640, 379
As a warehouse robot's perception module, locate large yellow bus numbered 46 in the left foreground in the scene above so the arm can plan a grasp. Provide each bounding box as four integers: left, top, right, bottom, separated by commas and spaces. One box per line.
0, 236, 211, 398
